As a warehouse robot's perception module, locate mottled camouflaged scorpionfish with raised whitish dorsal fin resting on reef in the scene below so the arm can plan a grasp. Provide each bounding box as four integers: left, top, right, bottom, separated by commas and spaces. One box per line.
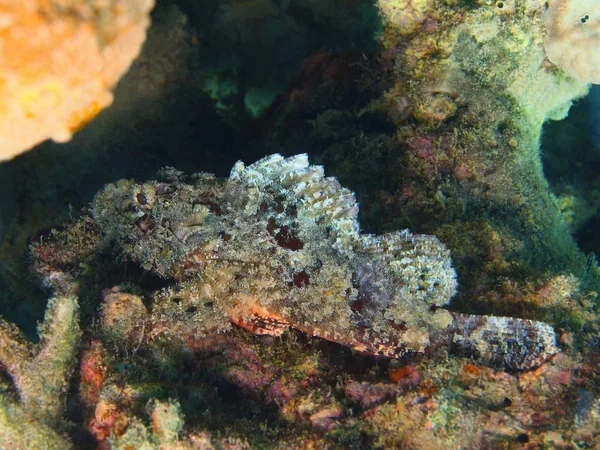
93, 154, 558, 369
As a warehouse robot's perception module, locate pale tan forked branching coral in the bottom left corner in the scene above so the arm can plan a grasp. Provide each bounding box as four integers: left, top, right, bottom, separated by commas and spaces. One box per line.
0, 295, 80, 450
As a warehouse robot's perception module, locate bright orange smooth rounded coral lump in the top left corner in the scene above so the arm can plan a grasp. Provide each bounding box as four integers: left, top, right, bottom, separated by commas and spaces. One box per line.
0, 0, 154, 161
